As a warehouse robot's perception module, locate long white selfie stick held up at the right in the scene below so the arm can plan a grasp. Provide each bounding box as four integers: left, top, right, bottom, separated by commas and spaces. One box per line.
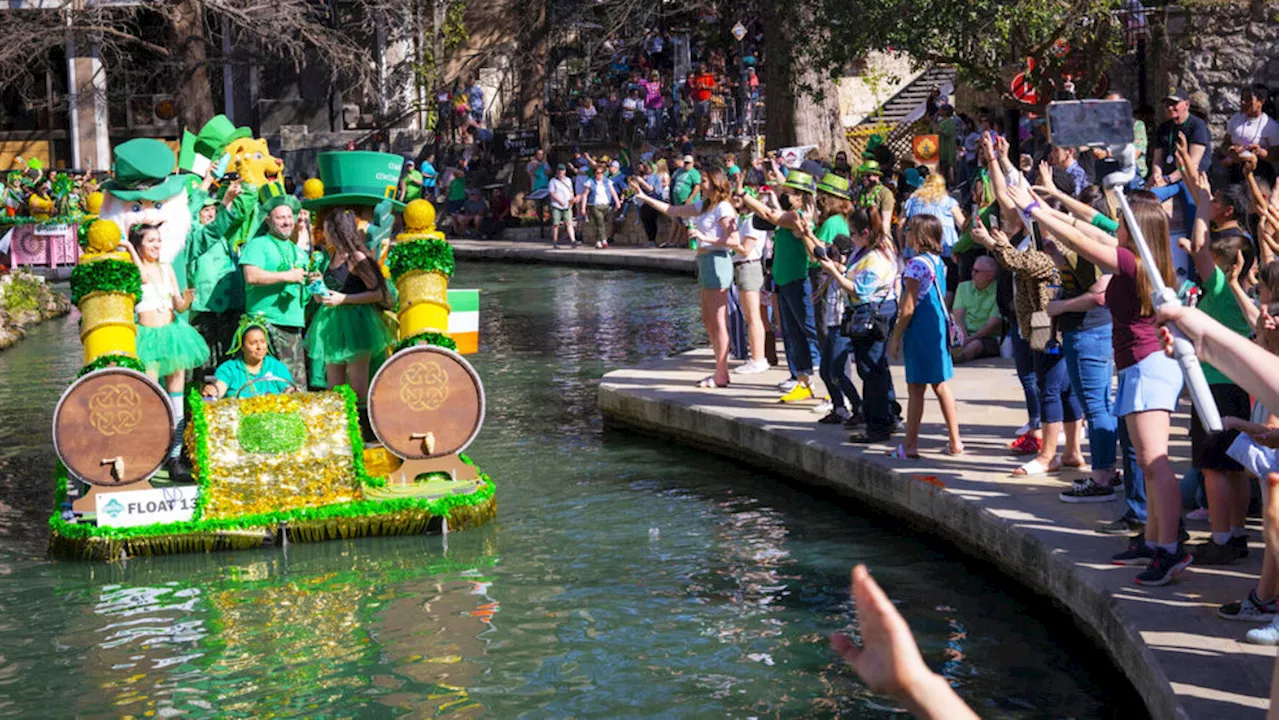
1102, 145, 1222, 433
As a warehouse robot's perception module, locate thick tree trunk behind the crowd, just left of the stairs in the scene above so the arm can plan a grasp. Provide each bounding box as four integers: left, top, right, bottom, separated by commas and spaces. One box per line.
764, 0, 846, 159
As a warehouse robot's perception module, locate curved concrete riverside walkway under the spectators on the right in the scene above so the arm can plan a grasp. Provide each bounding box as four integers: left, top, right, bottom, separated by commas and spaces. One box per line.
599, 350, 1276, 719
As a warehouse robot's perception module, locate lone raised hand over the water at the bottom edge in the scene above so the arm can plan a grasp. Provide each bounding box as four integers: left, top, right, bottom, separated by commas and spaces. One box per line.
831, 565, 978, 720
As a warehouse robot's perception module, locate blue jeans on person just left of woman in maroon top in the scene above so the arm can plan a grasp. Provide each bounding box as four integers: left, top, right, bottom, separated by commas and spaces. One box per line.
1062, 323, 1116, 470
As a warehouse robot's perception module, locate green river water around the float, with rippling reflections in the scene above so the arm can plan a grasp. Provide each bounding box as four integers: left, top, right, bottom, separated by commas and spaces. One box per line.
0, 265, 1140, 717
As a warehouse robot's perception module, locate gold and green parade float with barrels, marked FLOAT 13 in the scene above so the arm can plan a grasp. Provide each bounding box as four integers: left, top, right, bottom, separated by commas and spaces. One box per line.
49, 152, 497, 561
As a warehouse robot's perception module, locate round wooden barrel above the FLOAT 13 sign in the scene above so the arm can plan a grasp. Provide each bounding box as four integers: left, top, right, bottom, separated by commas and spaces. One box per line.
54, 368, 173, 487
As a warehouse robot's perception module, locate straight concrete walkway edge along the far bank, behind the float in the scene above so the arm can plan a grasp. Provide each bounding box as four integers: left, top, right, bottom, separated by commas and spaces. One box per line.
449, 239, 694, 275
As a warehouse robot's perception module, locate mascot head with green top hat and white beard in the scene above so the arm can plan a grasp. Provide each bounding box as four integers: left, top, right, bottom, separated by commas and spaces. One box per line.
99, 137, 191, 263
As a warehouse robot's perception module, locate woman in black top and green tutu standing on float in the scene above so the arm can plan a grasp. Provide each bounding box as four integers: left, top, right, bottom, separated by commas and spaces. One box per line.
306, 210, 394, 401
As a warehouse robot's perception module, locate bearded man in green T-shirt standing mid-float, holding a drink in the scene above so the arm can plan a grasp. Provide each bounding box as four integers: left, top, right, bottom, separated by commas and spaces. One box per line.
239, 184, 310, 382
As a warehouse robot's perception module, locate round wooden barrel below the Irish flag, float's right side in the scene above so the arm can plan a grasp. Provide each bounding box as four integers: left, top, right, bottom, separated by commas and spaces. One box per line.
369, 345, 484, 459
